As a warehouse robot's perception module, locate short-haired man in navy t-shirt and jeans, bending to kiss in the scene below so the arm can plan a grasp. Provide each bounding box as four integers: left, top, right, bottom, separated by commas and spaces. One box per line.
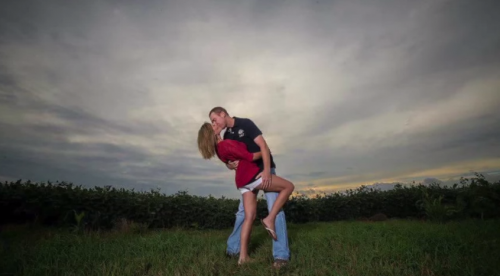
208, 107, 290, 268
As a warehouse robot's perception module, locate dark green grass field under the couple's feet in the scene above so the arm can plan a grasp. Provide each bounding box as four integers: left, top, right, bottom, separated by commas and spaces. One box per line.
0, 220, 500, 276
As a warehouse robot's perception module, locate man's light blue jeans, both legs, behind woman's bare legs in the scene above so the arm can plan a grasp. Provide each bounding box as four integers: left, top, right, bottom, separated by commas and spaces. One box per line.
227, 169, 290, 261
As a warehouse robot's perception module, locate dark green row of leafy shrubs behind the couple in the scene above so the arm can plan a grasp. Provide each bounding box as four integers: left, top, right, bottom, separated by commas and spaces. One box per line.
0, 174, 500, 229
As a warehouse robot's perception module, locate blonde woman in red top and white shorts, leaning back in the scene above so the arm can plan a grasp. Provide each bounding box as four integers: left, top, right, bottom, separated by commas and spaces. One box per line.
198, 123, 294, 264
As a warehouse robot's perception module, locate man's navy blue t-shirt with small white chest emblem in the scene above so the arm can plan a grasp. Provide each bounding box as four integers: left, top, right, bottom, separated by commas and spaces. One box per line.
223, 117, 276, 169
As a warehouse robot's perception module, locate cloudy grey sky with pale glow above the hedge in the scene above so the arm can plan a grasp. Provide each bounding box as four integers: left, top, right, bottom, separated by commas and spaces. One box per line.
0, 0, 500, 197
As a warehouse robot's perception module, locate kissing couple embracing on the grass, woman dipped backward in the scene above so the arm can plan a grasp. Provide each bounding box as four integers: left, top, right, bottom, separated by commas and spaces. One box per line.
198, 107, 295, 268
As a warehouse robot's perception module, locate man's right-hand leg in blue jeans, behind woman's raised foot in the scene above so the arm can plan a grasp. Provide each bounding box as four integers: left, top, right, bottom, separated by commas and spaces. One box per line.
264, 169, 290, 261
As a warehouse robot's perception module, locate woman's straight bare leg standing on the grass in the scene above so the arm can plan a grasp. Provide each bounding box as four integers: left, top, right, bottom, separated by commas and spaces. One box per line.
238, 190, 258, 264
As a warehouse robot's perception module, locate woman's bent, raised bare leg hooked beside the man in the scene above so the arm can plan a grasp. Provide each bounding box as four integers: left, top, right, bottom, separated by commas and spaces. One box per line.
257, 175, 295, 237
